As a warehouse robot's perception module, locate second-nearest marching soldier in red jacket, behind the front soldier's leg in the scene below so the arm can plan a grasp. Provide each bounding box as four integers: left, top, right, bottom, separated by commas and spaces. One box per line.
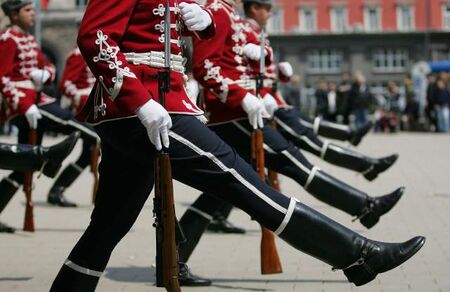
180, 0, 410, 278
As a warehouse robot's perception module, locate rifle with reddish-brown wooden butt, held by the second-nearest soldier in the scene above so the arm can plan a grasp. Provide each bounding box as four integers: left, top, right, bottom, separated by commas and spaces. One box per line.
251, 28, 282, 274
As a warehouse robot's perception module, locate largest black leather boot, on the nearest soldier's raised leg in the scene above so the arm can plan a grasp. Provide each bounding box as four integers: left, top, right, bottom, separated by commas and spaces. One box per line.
276, 200, 425, 286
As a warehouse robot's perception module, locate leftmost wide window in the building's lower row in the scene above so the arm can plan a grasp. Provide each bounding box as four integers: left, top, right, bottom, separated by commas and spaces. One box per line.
306, 49, 344, 73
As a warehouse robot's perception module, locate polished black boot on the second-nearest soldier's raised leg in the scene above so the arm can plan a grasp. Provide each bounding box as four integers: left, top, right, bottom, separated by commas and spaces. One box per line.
304, 167, 405, 228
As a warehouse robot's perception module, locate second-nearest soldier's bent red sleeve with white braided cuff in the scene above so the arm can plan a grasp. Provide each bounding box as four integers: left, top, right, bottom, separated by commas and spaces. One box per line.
192, 9, 247, 107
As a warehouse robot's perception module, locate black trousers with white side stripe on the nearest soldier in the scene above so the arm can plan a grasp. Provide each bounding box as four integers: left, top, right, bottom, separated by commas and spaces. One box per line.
66, 115, 290, 273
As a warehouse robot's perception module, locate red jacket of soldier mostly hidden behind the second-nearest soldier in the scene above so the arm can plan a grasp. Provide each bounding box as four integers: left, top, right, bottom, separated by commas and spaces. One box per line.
245, 18, 290, 107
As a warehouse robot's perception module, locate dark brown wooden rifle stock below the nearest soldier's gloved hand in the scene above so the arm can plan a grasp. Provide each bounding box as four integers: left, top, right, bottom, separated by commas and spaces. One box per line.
155, 152, 181, 292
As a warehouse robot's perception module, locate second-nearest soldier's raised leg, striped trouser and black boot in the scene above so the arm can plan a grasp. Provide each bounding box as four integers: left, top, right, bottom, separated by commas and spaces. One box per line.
225, 121, 404, 228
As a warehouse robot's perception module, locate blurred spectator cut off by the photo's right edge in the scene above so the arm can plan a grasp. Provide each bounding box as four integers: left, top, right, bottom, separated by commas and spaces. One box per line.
434, 79, 450, 132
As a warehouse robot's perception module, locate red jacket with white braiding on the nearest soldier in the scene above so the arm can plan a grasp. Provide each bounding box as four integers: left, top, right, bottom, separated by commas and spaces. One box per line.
78, 0, 215, 123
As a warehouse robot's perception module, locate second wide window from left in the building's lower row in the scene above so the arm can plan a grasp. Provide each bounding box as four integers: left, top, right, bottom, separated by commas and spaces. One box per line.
373, 49, 409, 73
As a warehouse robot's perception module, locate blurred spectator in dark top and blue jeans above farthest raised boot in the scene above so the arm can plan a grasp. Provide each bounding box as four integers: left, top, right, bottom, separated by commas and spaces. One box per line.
349, 71, 373, 128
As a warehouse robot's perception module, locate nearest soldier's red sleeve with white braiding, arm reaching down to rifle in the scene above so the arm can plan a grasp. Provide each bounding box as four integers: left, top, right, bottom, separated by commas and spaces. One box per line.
78, 0, 151, 112
